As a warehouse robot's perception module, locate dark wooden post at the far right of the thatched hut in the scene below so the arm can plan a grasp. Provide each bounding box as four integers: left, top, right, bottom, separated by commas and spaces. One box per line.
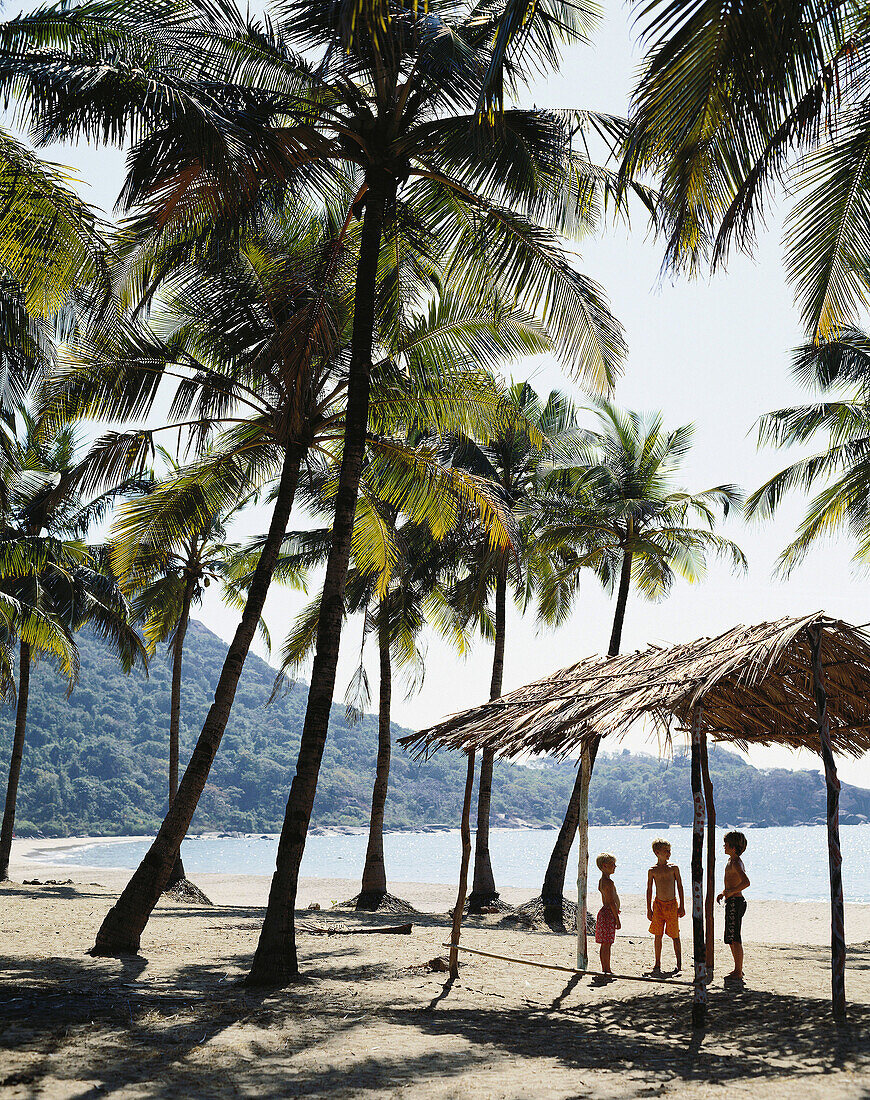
807, 626, 846, 1023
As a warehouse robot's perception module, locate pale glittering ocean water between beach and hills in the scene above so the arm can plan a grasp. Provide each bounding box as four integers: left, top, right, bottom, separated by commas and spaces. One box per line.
32, 825, 870, 902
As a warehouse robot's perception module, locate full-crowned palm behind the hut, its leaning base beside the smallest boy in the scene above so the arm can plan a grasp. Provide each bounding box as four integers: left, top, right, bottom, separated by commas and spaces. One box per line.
533, 402, 746, 927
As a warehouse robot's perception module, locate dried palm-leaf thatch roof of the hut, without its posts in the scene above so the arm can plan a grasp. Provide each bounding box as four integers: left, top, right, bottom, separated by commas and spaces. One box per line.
401, 612, 870, 758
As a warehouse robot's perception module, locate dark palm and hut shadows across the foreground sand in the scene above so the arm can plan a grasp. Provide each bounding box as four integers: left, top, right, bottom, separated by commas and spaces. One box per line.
0, 937, 870, 1100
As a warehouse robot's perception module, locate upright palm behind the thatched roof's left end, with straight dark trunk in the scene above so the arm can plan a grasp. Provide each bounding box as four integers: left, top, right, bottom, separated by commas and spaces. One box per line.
442, 382, 579, 912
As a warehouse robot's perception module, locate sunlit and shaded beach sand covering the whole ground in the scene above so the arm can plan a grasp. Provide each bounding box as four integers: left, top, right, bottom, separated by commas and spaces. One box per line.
0, 842, 870, 1100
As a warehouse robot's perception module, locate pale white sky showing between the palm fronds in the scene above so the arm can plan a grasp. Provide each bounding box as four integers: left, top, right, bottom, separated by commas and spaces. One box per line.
11, 0, 870, 787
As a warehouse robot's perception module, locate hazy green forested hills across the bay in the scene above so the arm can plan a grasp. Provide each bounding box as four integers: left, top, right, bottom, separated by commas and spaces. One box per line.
0, 623, 870, 836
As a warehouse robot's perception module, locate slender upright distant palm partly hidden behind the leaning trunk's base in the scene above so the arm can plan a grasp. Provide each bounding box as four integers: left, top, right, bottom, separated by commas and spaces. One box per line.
110, 448, 257, 904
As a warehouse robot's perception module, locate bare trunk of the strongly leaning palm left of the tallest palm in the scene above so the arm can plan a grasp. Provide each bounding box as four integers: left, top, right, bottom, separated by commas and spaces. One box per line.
91, 443, 306, 955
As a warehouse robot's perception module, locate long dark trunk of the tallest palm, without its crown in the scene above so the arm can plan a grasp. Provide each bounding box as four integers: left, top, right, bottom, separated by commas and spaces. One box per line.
247, 168, 395, 986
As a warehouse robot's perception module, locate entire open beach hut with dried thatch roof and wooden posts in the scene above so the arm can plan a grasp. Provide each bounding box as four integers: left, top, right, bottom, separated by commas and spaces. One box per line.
400, 612, 870, 1026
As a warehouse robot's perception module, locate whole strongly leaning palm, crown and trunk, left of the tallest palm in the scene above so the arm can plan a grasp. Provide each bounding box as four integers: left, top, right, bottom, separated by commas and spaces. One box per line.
44, 207, 350, 954
